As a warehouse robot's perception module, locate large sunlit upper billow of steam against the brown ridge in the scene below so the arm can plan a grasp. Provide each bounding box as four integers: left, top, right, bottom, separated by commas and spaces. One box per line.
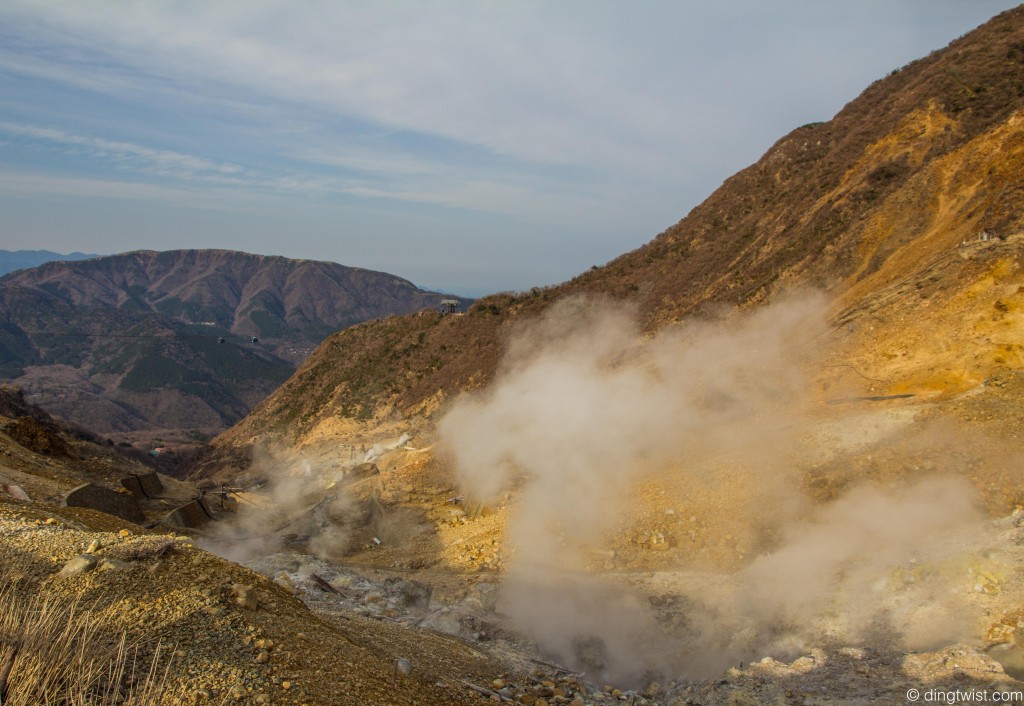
439, 297, 823, 566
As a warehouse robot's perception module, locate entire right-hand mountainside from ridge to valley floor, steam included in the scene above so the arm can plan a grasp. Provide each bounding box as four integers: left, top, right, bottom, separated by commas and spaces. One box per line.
172, 7, 1024, 692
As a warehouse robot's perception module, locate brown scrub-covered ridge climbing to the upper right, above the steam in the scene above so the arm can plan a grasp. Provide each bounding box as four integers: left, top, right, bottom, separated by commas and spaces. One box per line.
216, 8, 1024, 459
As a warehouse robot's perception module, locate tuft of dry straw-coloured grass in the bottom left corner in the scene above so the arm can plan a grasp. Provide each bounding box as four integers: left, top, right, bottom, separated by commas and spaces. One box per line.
0, 586, 171, 706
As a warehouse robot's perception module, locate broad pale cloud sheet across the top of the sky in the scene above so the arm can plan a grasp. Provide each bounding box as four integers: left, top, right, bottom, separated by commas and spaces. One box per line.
0, 0, 1005, 187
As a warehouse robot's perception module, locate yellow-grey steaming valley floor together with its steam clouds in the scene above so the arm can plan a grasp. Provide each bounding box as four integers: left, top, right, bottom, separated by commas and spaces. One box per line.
197, 295, 1024, 703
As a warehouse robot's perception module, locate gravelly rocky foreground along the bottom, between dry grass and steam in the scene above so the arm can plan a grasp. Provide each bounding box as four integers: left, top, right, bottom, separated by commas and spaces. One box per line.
8, 489, 1024, 706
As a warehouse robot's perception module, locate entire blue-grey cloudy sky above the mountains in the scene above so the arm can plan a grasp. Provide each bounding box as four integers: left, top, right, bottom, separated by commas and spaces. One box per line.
0, 0, 1017, 296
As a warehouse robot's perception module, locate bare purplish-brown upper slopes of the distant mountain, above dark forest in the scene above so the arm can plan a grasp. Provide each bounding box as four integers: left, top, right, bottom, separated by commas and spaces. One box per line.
0, 250, 468, 362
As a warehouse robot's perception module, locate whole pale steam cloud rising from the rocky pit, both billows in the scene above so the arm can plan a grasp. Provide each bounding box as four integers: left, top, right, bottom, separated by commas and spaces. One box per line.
439, 295, 982, 680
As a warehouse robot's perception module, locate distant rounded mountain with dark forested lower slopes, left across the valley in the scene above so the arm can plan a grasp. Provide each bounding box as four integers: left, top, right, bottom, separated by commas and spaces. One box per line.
0, 250, 470, 438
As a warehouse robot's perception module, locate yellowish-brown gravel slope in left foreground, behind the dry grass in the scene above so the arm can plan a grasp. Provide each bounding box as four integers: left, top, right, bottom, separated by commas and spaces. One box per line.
0, 503, 500, 704
